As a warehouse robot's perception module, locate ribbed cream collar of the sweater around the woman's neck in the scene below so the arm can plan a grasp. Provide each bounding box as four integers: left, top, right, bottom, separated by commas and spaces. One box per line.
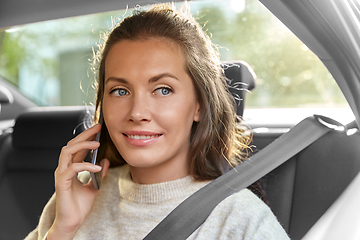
119, 165, 209, 203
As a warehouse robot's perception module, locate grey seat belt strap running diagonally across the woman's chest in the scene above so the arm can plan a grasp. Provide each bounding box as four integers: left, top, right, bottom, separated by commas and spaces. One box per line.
144, 115, 345, 240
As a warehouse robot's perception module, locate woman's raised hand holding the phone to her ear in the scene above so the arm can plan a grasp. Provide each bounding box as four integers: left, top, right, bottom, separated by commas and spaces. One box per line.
47, 124, 109, 240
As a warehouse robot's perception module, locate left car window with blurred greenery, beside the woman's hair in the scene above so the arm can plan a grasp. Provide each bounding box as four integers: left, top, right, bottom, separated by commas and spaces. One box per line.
0, 10, 131, 106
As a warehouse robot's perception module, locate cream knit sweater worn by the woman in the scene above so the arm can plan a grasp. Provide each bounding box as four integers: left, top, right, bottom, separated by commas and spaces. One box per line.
26, 165, 289, 240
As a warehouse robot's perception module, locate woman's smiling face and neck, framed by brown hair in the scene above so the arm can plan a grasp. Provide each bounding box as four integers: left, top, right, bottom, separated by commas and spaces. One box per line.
103, 39, 200, 183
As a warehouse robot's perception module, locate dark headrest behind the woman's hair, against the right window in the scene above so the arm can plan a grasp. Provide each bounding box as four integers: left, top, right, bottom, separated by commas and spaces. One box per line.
222, 61, 256, 116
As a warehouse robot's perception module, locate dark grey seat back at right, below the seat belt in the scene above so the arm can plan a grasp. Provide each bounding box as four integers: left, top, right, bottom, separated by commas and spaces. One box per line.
260, 122, 360, 240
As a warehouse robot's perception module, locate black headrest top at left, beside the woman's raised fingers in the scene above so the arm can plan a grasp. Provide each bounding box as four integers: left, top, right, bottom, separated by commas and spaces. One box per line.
13, 106, 94, 148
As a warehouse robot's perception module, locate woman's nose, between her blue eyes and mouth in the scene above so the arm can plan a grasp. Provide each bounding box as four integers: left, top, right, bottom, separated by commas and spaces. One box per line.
129, 93, 151, 122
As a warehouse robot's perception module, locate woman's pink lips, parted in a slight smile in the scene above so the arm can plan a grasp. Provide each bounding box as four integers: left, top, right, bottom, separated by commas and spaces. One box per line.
123, 131, 162, 147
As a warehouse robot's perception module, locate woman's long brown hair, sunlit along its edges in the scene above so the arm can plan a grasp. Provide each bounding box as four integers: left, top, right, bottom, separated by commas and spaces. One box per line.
91, 4, 249, 180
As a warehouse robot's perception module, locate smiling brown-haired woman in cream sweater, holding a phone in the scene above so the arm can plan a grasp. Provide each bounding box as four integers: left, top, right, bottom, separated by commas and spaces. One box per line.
28, 5, 288, 240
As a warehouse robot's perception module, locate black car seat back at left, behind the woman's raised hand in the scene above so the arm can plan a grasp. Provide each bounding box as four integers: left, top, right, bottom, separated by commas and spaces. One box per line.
0, 107, 93, 239
